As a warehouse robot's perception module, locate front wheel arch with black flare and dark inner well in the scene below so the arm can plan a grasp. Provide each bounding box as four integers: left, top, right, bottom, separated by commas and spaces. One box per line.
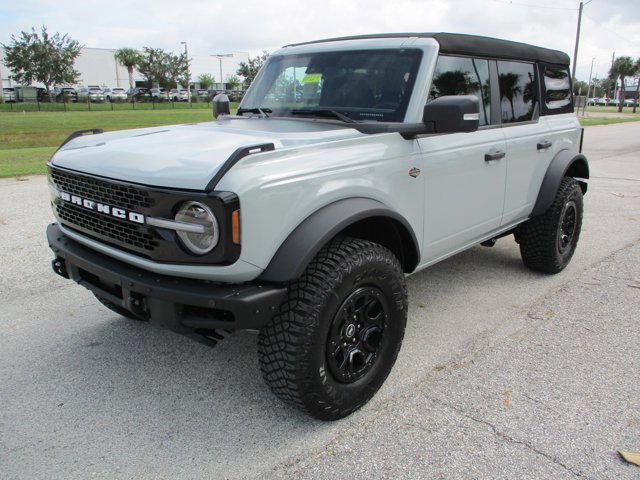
259, 198, 420, 283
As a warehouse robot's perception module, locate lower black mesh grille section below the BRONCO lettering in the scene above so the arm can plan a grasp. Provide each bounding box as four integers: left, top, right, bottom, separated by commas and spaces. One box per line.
56, 202, 159, 252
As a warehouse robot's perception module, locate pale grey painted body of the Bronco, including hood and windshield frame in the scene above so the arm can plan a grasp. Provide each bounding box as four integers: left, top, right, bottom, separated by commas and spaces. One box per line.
47, 38, 580, 282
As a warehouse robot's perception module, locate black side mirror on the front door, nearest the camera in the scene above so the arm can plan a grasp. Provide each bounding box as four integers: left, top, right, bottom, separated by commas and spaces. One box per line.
422, 95, 480, 133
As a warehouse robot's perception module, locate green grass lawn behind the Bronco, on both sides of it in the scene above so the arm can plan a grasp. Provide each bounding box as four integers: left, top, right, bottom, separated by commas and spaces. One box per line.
0, 104, 640, 177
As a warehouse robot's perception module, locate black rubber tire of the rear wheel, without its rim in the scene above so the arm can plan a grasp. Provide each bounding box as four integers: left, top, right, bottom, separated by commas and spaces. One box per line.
515, 177, 583, 274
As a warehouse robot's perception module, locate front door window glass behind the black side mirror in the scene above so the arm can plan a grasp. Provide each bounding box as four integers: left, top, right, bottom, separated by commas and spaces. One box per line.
429, 55, 491, 125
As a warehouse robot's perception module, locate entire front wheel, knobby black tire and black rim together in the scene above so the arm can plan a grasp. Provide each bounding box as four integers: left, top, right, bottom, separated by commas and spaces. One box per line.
258, 237, 407, 420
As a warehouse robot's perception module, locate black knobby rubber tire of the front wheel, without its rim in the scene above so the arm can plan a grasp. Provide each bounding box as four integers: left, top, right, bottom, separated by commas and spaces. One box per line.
258, 237, 407, 420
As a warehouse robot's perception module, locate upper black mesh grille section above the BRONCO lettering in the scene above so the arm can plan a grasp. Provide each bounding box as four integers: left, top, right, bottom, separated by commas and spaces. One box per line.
51, 170, 154, 212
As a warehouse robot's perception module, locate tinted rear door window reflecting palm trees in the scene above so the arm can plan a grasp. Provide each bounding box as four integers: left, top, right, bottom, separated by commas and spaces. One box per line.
498, 61, 538, 124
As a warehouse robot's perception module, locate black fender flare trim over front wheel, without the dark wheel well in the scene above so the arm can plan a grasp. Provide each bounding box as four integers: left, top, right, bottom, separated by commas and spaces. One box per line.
258, 197, 420, 283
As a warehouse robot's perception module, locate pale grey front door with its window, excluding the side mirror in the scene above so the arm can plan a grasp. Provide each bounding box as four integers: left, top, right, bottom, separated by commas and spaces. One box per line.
418, 55, 507, 262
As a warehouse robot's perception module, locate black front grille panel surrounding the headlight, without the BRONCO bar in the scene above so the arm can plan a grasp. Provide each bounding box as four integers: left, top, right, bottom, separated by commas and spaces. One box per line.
49, 165, 240, 264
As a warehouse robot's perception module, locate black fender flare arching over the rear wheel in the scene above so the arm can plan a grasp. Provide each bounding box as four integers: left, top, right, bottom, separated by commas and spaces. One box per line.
531, 150, 589, 217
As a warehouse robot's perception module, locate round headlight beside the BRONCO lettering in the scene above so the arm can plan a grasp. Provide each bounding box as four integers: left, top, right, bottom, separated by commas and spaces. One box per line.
176, 202, 220, 255
